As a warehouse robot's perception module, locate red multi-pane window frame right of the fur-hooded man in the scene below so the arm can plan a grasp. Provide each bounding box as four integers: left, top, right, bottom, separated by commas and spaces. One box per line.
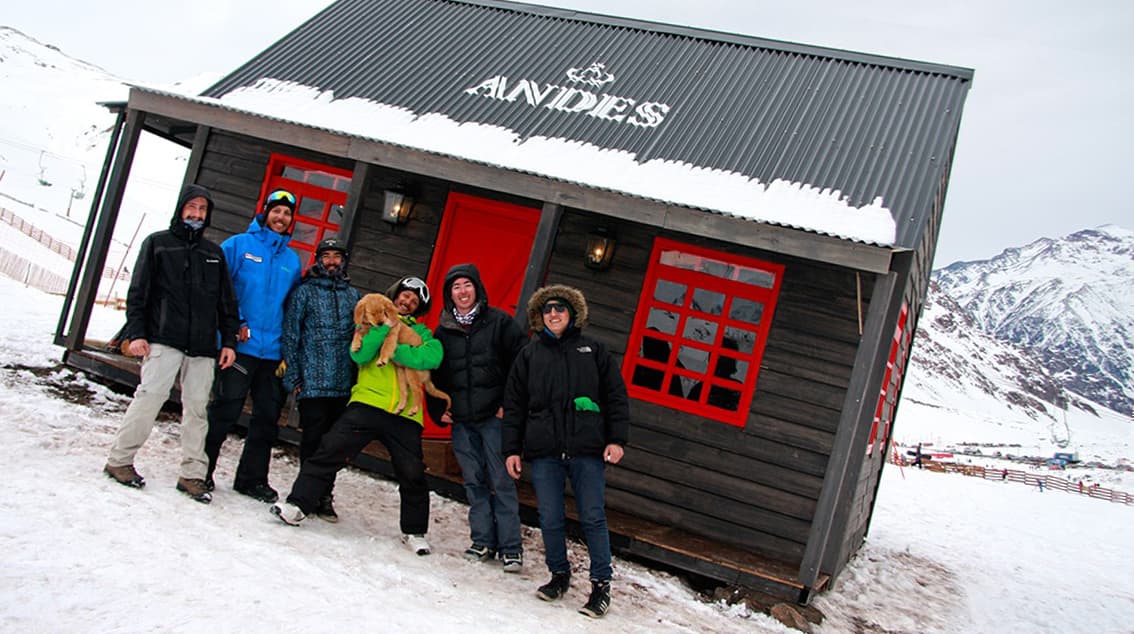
623, 238, 784, 426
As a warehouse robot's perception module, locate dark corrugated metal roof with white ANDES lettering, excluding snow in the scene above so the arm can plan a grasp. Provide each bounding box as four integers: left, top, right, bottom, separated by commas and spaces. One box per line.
203, 0, 972, 248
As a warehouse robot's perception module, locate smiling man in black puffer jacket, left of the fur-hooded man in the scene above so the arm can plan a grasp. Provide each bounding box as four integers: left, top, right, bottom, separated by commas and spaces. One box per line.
433, 264, 527, 573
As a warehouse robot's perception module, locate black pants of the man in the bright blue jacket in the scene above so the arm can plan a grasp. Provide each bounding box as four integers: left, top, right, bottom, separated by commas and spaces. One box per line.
205, 354, 287, 489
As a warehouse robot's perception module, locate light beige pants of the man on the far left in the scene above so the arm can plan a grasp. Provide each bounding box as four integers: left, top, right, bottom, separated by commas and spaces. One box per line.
107, 344, 217, 480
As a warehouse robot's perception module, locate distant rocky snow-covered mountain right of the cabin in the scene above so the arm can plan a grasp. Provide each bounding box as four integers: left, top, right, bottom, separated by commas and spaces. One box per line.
934, 226, 1134, 414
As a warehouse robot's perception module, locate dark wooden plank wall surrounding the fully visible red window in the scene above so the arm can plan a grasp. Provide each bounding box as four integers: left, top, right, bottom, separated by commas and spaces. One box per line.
547, 210, 873, 563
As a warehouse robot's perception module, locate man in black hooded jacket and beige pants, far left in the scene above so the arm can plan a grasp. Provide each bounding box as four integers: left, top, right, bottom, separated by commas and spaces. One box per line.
103, 185, 239, 504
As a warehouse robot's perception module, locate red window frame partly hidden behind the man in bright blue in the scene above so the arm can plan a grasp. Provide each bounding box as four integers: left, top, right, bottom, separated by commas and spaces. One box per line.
256, 153, 354, 268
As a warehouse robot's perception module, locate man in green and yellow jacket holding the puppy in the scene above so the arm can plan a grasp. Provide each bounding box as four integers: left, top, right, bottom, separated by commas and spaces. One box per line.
271, 277, 442, 555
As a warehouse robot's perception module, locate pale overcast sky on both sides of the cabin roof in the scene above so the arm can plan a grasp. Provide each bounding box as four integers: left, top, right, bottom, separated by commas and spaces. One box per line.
8, 0, 1134, 267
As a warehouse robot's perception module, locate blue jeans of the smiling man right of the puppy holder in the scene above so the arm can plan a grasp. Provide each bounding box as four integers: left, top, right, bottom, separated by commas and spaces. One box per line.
452, 416, 524, 553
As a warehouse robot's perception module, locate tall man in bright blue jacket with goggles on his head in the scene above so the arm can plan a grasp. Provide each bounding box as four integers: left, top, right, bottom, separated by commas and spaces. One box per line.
205, 189, 303, 504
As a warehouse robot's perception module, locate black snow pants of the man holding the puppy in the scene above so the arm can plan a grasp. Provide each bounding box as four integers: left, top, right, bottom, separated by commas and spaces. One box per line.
287, 403, 429, 535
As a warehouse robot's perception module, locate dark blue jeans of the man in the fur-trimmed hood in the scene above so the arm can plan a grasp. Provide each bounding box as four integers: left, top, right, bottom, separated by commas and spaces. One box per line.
531, 456, 612, 581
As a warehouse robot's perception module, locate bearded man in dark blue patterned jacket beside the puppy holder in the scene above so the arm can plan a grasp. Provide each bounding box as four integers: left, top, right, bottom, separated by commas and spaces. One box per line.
282, 238, 359, 522
